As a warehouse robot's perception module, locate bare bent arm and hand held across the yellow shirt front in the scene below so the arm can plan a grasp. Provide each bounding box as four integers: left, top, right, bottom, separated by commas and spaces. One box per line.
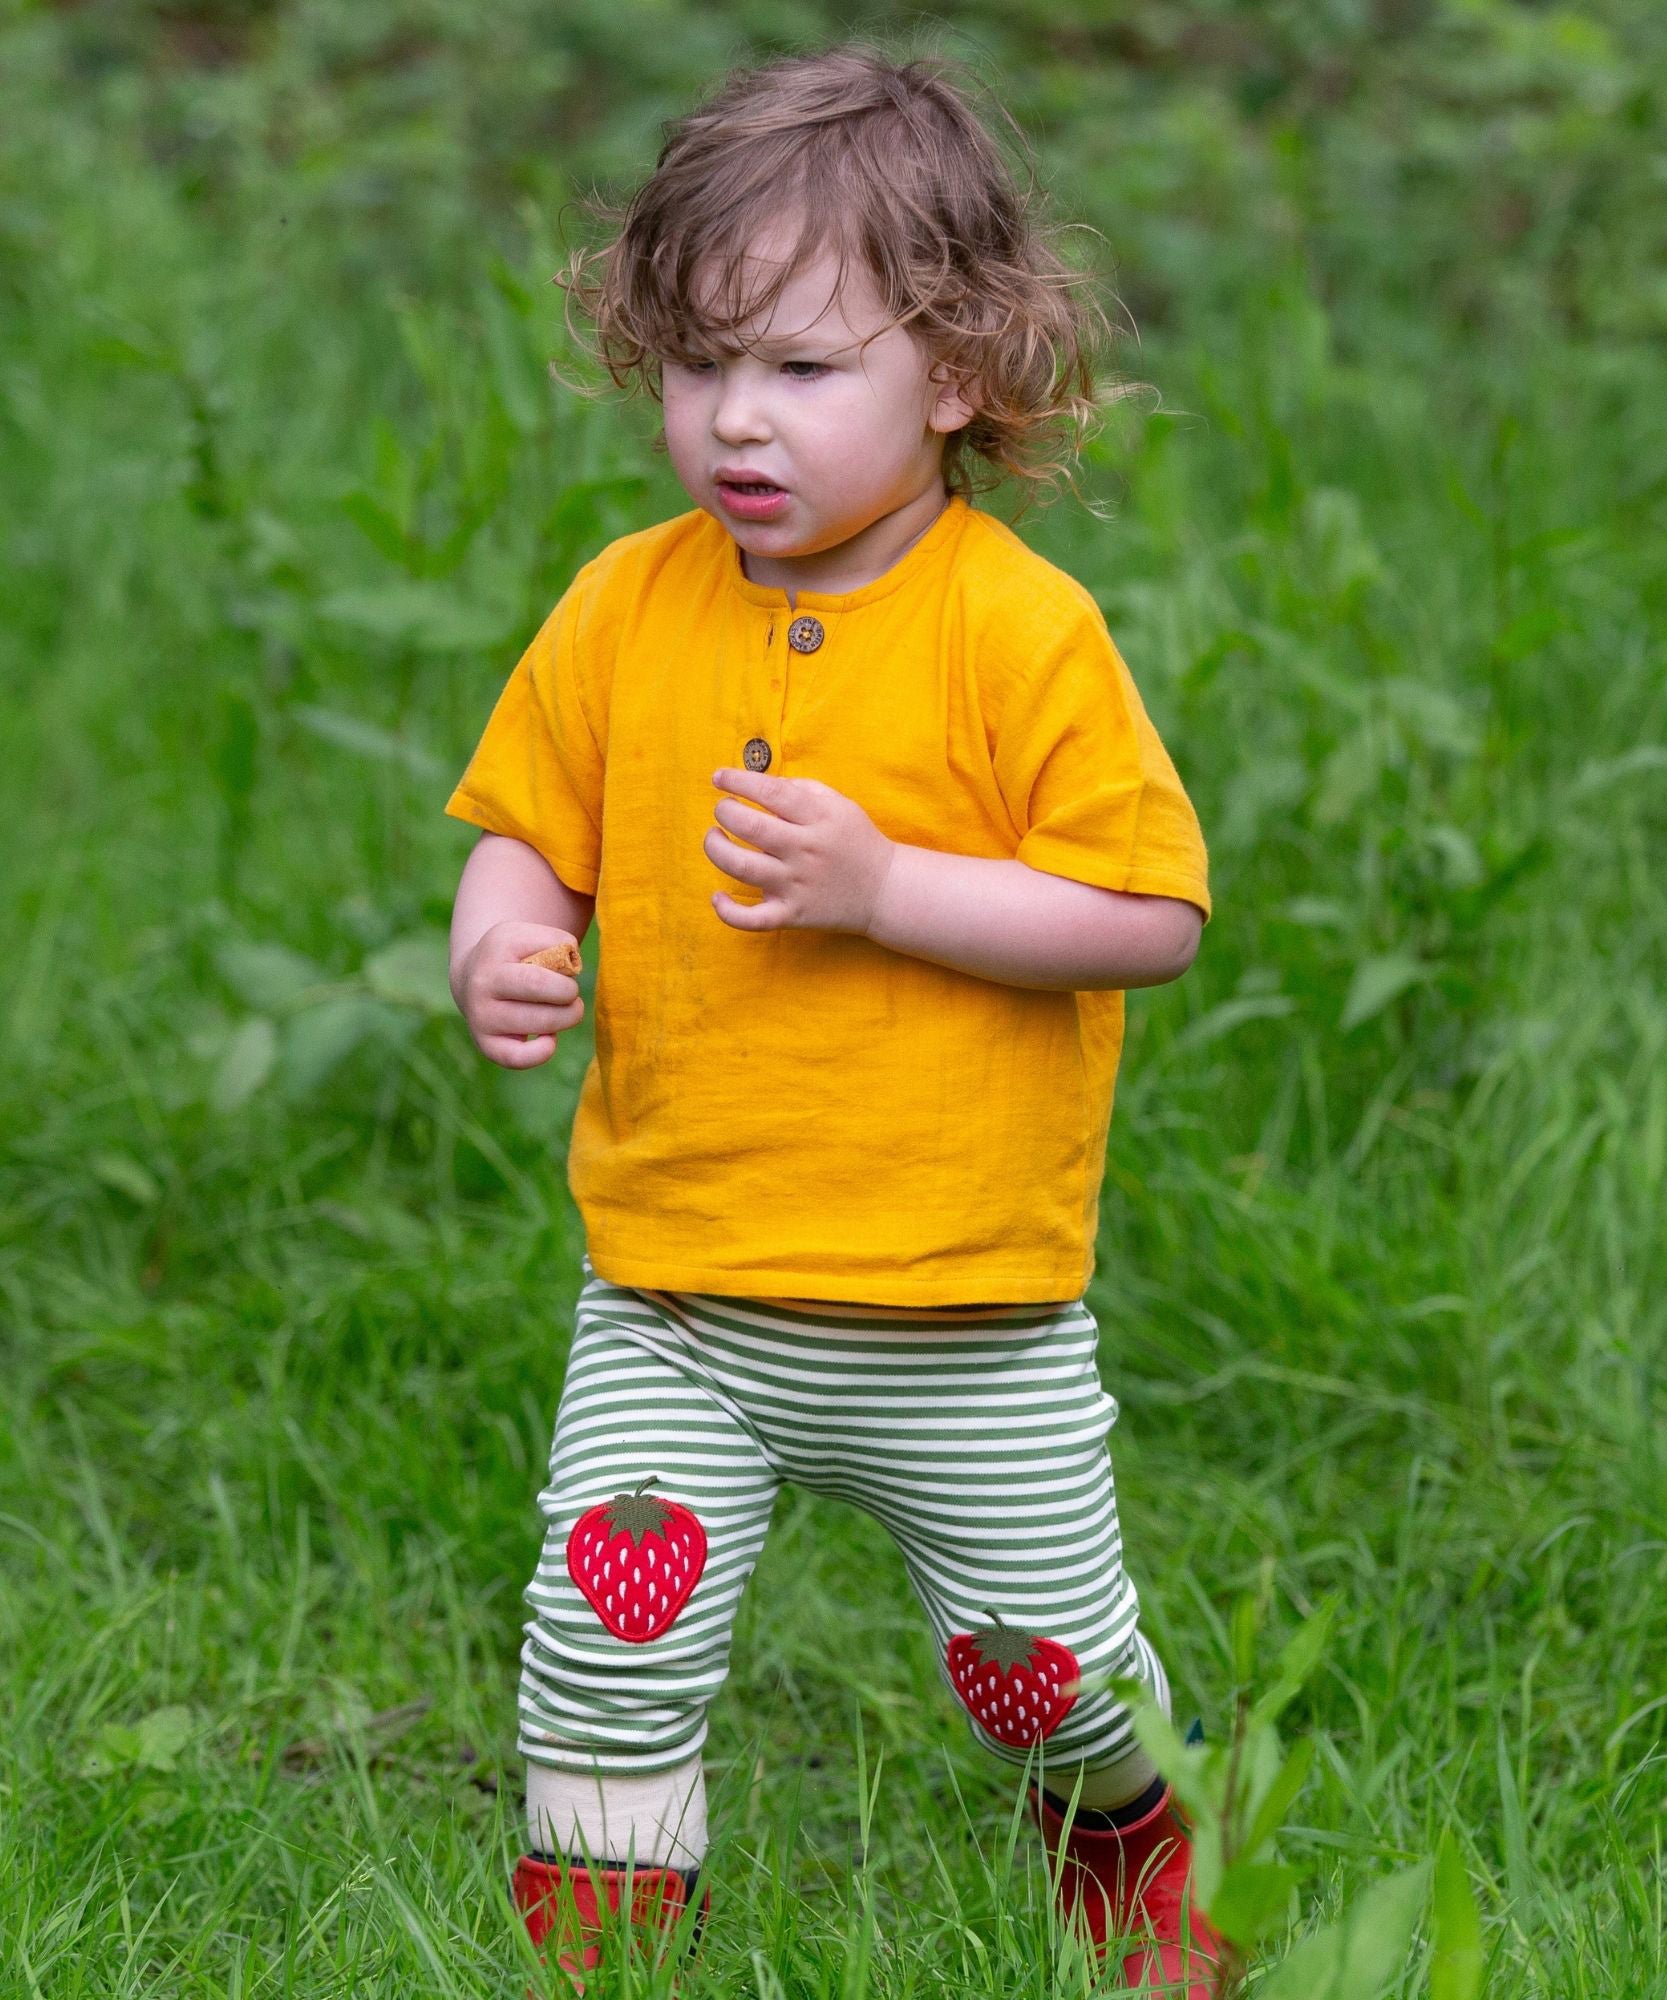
706, 768, 1203, 992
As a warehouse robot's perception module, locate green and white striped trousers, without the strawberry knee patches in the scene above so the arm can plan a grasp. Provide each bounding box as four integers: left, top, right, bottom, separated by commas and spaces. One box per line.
520, 1262, 1167, 1776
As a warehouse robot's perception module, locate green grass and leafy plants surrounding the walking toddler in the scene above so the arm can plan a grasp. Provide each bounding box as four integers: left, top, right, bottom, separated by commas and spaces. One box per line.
0, 8, 1667, 2000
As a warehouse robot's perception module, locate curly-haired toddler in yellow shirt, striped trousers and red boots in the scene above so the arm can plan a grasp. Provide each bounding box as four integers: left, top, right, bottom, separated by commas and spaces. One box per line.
446, 44, 1217, 1996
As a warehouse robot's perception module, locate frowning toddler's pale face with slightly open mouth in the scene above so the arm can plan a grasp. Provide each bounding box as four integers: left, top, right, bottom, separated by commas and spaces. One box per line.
662, 234, 971, 588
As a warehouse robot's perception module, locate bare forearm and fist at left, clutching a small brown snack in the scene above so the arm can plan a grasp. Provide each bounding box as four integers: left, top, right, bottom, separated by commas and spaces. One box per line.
452, 834, 596, 1070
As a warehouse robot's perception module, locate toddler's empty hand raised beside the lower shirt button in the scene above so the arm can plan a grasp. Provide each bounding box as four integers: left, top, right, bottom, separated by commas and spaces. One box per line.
702, 766, 895, 934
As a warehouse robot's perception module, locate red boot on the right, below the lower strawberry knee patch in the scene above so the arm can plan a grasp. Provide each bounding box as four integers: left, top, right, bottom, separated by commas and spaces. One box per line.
1031, 1790, 1221, 2000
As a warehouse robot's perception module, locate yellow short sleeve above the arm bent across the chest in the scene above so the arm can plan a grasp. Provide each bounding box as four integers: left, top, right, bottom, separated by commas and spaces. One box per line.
993, 606, 1209, 918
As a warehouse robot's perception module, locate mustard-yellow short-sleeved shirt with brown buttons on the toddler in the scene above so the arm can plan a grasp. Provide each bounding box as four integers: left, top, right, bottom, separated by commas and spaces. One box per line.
446, 496, 1209, 1308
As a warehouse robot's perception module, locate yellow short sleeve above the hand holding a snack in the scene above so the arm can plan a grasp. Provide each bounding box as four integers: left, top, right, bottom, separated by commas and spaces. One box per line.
446, 570, 604, 896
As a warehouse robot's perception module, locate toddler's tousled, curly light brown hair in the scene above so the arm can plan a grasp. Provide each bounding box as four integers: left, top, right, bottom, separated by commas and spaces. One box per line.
554, 42, 1133, 512
